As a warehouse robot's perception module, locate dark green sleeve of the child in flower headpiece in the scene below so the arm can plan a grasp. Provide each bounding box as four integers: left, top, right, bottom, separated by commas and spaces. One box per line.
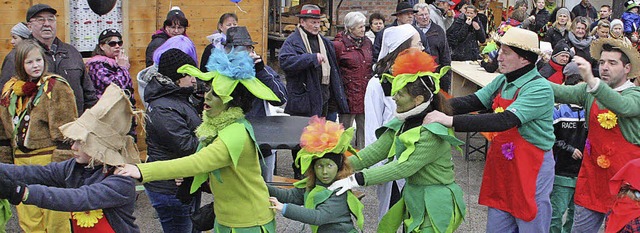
282, 193, 351, 226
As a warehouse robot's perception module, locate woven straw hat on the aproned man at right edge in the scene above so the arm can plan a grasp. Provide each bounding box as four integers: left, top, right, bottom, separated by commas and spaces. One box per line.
590, 38, 640, 77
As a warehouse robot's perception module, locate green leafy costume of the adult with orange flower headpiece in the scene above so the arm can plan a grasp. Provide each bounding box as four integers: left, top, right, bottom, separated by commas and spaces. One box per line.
349, 118, 466, 232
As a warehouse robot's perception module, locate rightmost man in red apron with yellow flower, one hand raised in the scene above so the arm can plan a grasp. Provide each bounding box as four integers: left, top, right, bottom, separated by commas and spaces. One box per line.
552, 39, 640, 233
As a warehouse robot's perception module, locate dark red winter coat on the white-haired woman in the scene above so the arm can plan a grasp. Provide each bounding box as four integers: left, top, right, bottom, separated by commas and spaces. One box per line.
333, 33, 373, 114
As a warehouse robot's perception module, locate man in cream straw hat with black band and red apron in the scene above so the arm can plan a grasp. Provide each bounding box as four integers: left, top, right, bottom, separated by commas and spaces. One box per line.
423, 28, 555, 233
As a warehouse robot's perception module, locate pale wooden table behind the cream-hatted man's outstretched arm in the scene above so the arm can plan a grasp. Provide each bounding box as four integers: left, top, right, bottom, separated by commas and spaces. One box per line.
451, 61, 500, 160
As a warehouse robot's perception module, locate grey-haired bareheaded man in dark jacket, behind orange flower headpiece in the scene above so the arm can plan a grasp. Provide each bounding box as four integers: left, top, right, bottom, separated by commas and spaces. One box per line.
413, 3, 451, 92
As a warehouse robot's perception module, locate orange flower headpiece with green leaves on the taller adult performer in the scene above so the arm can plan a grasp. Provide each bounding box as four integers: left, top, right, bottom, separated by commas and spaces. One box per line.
382, 48, 451, 95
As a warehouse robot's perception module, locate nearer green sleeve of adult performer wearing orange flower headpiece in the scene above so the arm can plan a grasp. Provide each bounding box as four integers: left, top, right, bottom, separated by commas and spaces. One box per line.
362, 128, 442, 186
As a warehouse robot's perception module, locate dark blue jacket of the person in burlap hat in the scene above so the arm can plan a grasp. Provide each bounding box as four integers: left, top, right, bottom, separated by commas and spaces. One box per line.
0, 159, 140, 233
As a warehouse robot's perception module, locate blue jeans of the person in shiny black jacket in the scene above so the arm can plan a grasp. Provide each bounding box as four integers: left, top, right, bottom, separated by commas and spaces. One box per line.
145, 190, 193, 233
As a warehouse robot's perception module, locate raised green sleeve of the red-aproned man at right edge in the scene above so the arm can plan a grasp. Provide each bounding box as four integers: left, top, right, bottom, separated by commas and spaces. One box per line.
591, 84, 640, 117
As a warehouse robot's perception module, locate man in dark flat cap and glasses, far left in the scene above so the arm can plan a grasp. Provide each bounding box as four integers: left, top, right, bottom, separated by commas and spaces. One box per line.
0, 4, 98, 115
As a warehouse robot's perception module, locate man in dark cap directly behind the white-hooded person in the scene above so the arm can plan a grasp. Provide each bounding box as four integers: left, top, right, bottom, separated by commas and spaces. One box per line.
373, 1, 431, 62
